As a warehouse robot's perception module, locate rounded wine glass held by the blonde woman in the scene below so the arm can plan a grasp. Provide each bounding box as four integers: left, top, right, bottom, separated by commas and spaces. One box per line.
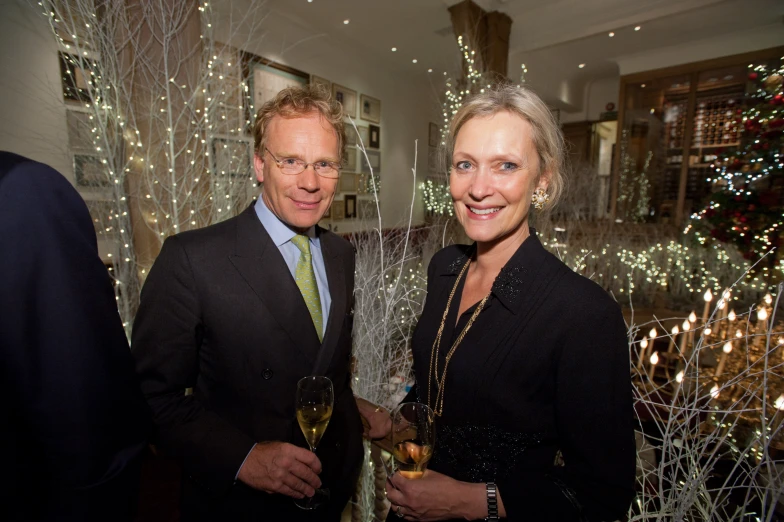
392, 402, 436, 479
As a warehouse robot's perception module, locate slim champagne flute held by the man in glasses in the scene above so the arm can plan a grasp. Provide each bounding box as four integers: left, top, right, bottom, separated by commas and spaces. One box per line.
294, 375, 334, 510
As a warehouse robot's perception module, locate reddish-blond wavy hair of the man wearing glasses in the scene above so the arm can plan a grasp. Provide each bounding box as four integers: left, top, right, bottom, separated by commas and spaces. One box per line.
253, 84, 346, 162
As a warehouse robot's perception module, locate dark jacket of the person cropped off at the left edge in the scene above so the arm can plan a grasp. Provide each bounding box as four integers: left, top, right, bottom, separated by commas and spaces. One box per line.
0, 152, 150, 521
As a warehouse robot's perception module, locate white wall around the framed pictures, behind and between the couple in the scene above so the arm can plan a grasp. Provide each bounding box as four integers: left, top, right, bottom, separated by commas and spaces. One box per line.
216, 2, 440, 233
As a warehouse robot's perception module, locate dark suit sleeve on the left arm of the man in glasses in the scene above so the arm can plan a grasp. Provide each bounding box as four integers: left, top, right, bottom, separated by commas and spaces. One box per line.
131, 236, 255, 494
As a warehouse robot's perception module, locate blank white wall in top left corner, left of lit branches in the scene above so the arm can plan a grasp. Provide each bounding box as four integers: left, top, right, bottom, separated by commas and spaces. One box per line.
0, 0, 73, 183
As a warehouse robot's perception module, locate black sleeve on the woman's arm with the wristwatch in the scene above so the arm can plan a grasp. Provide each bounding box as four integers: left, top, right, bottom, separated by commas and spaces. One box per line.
499, 303, 636, 522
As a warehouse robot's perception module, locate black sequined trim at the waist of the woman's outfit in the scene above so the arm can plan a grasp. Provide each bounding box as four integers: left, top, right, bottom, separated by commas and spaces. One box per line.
432, 424, 544, 482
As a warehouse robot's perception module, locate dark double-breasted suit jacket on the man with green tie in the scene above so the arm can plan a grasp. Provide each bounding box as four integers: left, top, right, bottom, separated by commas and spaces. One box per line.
132, 201, 363, 521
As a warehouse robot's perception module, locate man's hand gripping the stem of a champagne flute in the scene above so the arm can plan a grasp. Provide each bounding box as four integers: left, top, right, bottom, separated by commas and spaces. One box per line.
237, 442, 321, 498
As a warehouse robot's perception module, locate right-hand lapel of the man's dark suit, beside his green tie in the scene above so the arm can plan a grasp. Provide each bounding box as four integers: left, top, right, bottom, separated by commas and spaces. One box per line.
313, 230, 348, 375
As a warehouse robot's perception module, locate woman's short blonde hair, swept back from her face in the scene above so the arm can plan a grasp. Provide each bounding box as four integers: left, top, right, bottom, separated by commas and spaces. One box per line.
446, 84, 566, 210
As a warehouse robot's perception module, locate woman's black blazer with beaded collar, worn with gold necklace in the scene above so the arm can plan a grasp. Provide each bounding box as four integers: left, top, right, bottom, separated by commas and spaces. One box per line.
412, 229, 635, 522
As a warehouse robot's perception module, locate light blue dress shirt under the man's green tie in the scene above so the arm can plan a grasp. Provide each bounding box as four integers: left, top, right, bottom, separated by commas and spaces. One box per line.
254, 195, 332, 337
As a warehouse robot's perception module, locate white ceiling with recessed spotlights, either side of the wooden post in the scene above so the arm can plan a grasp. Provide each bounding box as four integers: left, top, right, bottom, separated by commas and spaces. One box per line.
256, 0, 784, 110
